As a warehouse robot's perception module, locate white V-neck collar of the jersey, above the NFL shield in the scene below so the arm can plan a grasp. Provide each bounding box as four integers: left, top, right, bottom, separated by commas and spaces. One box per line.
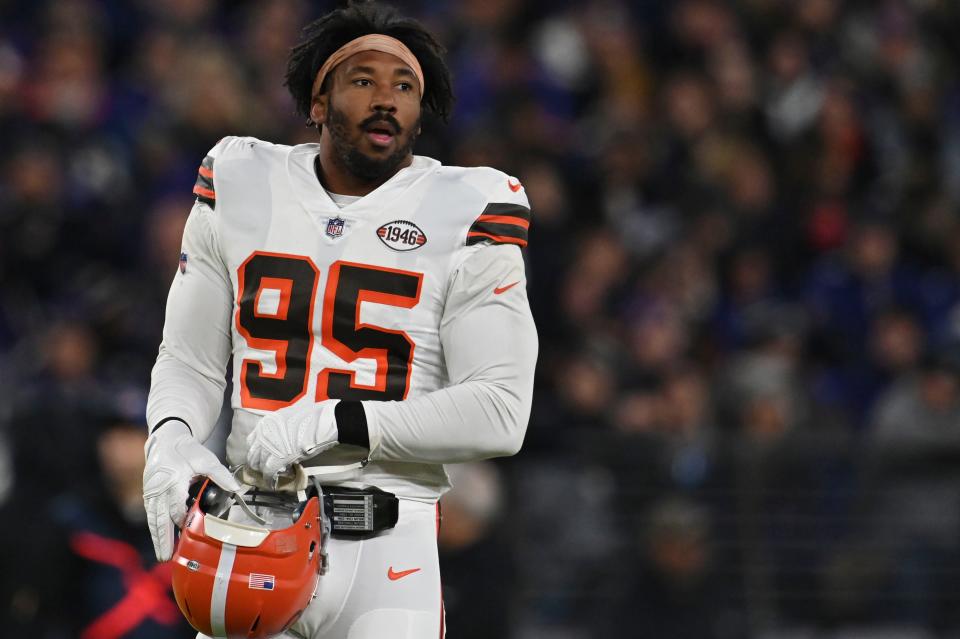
287, 143, 440, 217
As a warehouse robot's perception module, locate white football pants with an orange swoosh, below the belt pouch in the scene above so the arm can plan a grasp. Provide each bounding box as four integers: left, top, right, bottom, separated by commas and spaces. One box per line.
197, 499, 444, 639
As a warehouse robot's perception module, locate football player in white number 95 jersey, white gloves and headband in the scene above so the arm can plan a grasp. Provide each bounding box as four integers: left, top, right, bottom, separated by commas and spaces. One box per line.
144, 3, 537, 639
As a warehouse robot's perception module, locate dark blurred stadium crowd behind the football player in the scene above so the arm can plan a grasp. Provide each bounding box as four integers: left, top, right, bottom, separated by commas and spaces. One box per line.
0, 0, 960, 639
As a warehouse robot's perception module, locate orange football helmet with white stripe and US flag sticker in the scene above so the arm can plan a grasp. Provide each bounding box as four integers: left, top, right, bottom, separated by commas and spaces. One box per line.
173, 479, 324, 639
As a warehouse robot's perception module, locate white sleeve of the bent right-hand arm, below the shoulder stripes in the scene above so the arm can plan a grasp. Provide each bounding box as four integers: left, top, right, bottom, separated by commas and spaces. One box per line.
364, 180, 538, 463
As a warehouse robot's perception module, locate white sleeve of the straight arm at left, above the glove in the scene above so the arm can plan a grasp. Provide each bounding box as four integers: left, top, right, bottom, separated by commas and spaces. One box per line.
147, 142, 233, 441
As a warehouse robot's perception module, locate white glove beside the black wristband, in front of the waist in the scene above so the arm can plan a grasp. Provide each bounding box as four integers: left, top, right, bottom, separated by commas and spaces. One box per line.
247, 399, 340, 482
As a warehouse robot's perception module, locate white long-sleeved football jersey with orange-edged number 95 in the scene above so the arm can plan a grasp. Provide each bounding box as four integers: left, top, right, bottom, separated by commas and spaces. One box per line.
148, 137, 537, 500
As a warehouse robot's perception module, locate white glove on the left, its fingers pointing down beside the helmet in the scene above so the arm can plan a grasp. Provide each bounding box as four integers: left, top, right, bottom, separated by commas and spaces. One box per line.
143, 421, 240, 561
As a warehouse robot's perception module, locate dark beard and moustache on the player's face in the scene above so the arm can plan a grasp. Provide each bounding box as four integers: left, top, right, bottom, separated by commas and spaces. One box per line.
324, 105, 420, 182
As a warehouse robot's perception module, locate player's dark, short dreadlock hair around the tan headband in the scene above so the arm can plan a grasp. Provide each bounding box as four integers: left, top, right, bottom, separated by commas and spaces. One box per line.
284, 1, 454, 124
